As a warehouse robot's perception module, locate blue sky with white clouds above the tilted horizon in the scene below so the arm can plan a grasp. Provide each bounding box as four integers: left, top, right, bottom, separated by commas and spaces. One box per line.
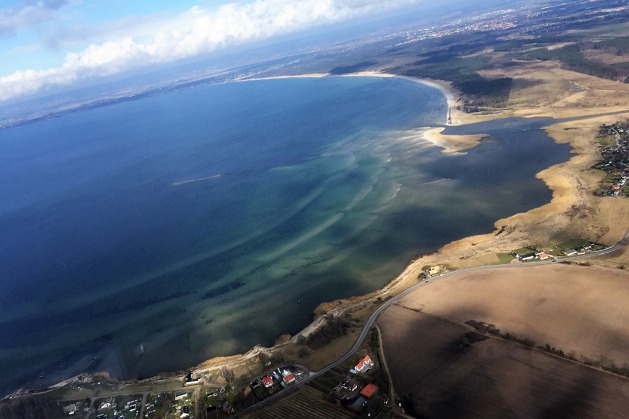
0, 0, 428, 101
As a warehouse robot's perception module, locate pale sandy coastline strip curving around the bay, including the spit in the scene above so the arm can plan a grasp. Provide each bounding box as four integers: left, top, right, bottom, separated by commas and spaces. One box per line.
188, 71, 629, 371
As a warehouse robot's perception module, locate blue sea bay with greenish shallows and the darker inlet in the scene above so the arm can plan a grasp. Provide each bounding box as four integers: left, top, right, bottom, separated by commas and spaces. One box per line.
0, 77, 569, 392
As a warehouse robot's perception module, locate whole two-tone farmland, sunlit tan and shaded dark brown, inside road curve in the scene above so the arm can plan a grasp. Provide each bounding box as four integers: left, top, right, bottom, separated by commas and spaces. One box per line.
378, 264, 629, 417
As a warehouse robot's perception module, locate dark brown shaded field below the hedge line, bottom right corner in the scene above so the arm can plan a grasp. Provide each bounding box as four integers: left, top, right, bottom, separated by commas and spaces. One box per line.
410, 339, 629, 418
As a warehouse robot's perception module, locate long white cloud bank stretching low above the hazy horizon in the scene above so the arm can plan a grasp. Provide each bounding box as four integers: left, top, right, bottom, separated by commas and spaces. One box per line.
0, 0, 413, 100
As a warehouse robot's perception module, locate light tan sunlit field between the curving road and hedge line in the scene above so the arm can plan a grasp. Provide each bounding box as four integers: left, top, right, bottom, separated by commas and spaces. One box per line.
393, 264, 629, 366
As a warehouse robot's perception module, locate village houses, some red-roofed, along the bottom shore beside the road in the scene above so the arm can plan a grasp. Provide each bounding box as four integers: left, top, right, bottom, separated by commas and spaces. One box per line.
56, 355, 389, 419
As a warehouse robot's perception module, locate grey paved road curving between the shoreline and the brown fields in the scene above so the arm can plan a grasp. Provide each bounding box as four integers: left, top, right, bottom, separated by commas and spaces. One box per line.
237, 230, 629, 416
